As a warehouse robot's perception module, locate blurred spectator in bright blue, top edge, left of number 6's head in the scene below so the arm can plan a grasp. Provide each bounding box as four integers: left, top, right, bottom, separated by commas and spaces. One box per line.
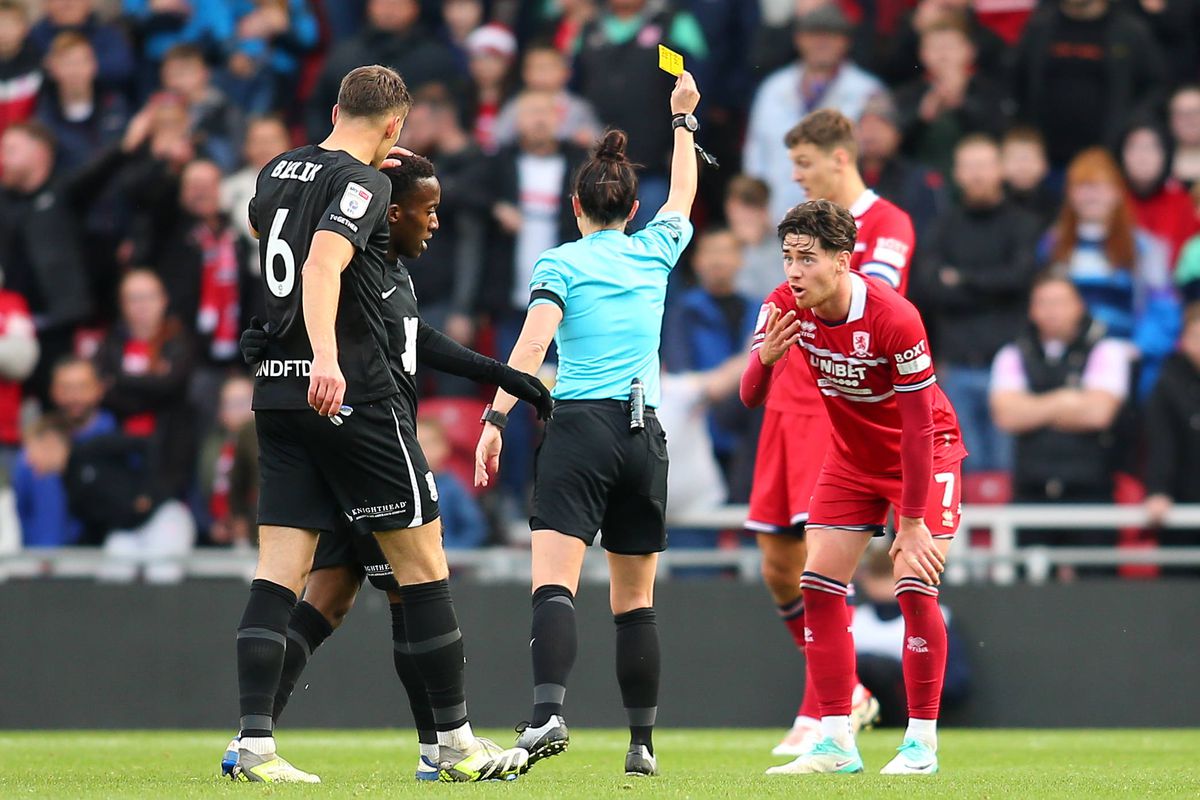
218, 0, 320, 114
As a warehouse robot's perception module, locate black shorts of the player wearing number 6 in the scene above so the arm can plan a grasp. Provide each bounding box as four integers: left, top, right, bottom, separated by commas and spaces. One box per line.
254, 396, 439, 535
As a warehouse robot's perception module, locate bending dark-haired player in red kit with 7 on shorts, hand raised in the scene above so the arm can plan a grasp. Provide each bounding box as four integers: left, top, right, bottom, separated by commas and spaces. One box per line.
742, 200, 966, 775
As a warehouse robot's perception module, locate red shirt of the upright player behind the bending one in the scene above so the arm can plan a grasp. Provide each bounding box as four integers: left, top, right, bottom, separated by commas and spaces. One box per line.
755, 190, 916, 414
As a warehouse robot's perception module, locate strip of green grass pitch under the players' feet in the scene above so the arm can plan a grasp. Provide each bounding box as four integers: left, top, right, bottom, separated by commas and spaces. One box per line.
0, 729, 1200, 800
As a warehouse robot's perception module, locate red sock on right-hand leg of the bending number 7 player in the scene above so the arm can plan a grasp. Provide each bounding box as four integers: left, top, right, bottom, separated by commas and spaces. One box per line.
902, 578, 947, 720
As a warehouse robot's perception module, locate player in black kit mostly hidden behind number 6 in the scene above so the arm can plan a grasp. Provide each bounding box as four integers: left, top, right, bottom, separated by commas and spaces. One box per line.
222, 156, 552, 781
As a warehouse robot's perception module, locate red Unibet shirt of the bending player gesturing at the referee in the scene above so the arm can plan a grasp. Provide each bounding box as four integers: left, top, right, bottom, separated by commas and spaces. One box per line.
785, 273, 967, 475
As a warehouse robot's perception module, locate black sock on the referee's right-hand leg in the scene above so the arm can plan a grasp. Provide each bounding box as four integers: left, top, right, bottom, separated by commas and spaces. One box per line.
612, 608, 662, 756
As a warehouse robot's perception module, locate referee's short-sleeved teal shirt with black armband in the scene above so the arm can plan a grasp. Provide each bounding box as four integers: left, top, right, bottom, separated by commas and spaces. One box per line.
529, 212, 692, 405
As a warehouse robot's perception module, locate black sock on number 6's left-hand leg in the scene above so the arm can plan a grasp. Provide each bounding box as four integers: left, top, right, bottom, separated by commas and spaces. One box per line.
238, 578, 296, 738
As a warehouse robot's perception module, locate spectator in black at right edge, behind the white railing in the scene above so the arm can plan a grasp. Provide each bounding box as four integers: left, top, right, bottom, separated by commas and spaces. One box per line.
1145, 303, 1200, 543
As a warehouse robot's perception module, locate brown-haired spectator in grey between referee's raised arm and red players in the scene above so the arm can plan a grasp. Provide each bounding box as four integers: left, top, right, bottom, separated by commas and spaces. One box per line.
725, 175, 784, 297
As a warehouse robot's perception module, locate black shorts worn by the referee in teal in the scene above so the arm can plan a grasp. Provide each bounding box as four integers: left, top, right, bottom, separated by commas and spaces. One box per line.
529, 401, 667, 555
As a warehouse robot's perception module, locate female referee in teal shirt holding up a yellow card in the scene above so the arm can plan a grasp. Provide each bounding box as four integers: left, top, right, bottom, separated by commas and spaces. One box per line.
475, 72, 700, 775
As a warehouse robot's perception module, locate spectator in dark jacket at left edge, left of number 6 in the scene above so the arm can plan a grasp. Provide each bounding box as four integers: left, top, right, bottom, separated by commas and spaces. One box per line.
0, 122, 92, 395
